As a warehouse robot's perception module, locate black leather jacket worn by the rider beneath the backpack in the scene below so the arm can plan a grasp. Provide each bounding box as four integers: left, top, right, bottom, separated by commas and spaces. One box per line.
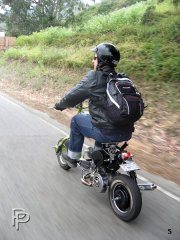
56, 67, 134, 133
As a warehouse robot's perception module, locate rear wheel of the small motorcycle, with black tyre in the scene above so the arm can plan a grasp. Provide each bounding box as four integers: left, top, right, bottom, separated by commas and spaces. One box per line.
109, 174, 142, 222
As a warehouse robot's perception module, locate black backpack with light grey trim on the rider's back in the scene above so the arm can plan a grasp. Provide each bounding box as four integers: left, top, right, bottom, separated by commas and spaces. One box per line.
105, 73, 144, 127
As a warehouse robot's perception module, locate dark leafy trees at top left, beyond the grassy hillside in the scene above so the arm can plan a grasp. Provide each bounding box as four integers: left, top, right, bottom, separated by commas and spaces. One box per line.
0, 0, 84, 36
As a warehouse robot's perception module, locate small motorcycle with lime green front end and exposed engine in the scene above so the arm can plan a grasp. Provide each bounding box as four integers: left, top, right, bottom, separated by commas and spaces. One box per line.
52, 104, 156, 222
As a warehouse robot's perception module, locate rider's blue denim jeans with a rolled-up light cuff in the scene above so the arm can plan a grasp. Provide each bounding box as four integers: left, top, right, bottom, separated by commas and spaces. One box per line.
68, 113, 132, 159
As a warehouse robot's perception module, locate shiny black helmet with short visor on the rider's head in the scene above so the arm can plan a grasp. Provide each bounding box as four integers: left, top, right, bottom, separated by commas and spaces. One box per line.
91, 43, 120, 67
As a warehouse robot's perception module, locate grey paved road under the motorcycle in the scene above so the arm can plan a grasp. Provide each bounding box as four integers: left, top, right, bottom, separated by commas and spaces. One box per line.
0, 93, 180, 240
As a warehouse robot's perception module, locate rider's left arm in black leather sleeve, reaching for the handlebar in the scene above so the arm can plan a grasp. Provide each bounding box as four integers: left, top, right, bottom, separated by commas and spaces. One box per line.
55, 71, 96, 110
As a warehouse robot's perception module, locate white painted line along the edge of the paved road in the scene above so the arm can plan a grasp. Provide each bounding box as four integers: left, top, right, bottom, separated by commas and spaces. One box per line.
0, 95, 180, 202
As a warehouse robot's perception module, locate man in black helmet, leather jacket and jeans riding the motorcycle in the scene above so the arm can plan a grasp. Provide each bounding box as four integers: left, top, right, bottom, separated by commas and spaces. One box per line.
55, 43, 134, 167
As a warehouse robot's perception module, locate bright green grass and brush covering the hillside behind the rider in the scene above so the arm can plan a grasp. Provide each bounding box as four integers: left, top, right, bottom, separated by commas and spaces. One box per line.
0, 0, 180, 110
